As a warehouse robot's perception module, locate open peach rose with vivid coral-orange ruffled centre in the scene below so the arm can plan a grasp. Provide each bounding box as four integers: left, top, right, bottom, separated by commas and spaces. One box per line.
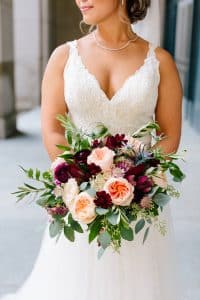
103, 177, 134, 206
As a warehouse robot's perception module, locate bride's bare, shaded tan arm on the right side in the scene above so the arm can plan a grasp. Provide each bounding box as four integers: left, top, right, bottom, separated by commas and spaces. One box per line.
153, 48, 183, 153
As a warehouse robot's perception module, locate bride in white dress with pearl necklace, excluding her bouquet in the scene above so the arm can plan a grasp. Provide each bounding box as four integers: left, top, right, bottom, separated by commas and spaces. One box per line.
3, 0, 183, 300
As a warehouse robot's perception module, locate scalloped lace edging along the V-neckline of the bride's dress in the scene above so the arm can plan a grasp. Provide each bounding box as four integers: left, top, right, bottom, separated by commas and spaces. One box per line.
74, 39, 151, 103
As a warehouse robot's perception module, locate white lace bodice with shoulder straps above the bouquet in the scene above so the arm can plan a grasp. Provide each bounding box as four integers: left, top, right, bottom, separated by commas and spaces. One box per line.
63, 40, 160, 143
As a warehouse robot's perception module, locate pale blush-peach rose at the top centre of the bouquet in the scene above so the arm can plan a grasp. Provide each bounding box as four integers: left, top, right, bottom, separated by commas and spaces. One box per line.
87, 146, 115, 171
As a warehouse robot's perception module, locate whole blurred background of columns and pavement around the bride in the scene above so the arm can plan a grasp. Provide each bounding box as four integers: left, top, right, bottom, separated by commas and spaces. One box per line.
0, 0, 200, 300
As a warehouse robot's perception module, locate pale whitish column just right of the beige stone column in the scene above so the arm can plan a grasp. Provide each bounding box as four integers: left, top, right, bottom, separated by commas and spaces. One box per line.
13, 0, 43, 111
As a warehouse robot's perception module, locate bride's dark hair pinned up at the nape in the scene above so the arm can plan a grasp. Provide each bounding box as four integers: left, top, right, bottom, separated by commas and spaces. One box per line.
126, 0, 151, 24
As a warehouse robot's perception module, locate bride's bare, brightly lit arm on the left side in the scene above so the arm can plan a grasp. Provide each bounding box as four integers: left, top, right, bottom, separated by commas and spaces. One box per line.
41, 45, 69, 161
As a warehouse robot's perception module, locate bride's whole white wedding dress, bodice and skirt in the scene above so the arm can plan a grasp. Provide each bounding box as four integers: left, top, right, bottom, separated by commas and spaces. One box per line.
1, 40, 181, 300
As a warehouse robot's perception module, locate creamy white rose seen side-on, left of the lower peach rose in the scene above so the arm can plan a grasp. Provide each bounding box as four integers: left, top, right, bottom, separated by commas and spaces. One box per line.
62, 178, 79, 208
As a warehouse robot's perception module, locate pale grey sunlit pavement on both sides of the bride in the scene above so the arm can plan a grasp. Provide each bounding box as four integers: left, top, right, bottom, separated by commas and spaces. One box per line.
0, 109, 200, 300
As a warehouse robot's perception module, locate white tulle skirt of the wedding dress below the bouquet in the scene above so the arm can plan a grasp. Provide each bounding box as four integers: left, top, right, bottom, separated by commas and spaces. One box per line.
1, 204, 182, 300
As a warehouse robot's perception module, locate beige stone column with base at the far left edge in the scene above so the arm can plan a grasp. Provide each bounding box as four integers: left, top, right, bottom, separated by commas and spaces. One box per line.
0, 0, 16, 138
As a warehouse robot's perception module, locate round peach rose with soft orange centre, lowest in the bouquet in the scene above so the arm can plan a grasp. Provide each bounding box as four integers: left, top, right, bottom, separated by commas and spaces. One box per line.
71, 191, 96, 224
